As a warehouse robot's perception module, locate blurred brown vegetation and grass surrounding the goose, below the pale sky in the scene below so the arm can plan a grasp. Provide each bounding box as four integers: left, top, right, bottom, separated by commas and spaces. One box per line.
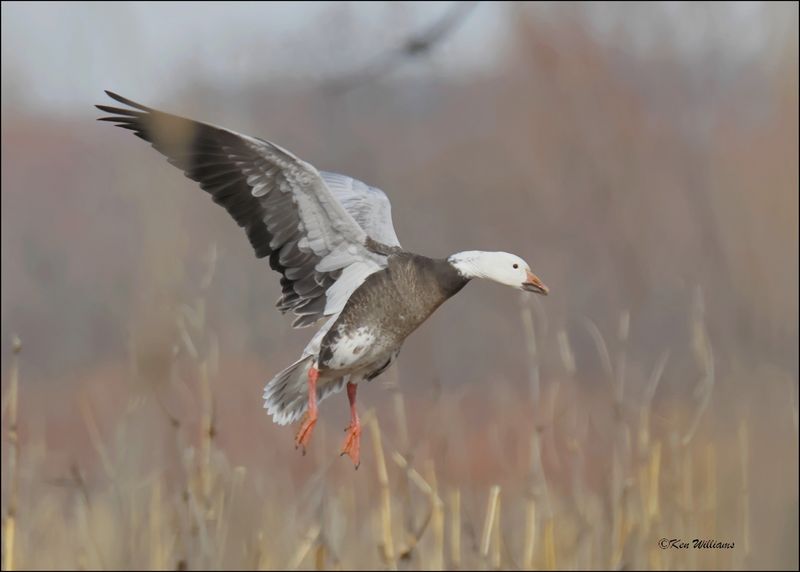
0, 4, 798, 569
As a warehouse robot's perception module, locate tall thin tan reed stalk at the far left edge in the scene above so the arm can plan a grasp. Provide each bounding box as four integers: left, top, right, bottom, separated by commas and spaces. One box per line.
3, 336, 22, 571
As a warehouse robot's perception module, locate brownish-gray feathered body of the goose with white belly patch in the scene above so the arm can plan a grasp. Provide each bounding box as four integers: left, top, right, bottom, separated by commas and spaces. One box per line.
318, 252, 468, 379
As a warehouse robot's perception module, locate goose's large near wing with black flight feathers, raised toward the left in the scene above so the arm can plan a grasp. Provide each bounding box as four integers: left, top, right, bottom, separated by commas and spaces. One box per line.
97, 91, 398, 327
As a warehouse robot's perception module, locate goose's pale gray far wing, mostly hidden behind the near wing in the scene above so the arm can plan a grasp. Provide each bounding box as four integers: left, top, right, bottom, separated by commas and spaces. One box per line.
319, 171, 400, 248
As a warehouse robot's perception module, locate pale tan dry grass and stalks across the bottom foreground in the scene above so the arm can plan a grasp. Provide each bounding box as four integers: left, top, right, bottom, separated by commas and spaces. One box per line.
4, 292, 796, 569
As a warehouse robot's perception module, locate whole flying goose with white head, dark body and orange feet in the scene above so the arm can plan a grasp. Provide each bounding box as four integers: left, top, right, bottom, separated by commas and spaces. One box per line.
97, 91, 548, 467
